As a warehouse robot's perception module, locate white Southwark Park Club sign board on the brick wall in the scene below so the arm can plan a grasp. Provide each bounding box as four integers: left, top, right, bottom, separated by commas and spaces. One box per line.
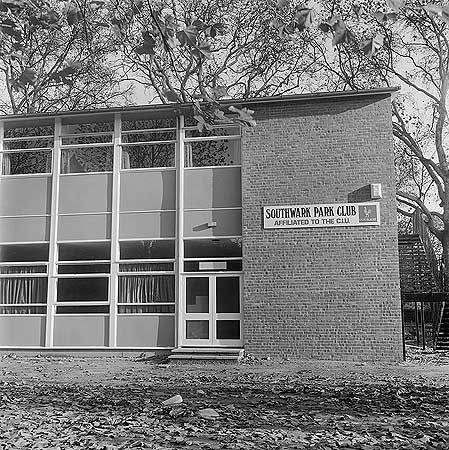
263, 203, 380, 229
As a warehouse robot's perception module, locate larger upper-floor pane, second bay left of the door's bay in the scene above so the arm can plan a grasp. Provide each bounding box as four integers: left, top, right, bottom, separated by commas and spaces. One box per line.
61, 147, 114, 173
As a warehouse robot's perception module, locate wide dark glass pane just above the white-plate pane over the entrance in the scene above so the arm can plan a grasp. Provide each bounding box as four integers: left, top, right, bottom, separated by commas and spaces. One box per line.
184, 238, 242, 258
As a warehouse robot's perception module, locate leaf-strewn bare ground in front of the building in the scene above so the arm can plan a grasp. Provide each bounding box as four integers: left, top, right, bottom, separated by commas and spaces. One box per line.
0, 348, 449, 450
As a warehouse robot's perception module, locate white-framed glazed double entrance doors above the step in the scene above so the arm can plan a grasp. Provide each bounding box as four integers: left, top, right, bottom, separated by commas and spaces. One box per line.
181, 274, 243, 347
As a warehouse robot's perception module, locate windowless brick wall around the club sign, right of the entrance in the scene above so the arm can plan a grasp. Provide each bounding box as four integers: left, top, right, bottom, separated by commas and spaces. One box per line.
242, 93, 402, 361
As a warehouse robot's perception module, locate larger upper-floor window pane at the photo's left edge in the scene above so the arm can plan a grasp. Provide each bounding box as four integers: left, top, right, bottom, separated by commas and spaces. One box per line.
2, 151, 51, 175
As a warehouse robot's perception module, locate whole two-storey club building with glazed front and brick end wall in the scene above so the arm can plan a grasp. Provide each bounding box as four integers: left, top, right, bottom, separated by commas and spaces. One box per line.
0, 89, 402, 361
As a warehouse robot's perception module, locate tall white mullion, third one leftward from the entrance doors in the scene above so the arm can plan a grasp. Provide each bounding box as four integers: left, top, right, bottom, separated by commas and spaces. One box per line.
45, 117, 62, 347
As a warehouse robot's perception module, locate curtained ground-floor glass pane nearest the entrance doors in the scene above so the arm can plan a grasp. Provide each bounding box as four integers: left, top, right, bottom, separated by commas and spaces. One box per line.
118, 275, 175, 303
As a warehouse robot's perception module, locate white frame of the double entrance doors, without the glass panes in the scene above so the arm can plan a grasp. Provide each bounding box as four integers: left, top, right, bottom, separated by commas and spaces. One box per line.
179, 272, 243, 347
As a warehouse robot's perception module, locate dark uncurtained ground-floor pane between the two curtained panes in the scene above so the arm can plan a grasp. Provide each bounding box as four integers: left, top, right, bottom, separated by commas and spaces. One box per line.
57, 278, 109, 302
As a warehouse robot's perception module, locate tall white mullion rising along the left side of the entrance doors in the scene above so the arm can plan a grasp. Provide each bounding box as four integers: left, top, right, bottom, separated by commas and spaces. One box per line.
175, 115, 185, 347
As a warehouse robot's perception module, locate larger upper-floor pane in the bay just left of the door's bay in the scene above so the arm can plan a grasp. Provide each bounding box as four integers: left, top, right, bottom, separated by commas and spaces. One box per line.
122, 144, 175, 169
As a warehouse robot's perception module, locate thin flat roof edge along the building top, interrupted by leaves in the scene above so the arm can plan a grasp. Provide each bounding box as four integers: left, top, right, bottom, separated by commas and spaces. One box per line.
0, 87, 400, 121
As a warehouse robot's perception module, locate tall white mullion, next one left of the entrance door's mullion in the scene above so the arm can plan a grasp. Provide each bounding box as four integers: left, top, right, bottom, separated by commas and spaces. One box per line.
109, 113, 122, 347
